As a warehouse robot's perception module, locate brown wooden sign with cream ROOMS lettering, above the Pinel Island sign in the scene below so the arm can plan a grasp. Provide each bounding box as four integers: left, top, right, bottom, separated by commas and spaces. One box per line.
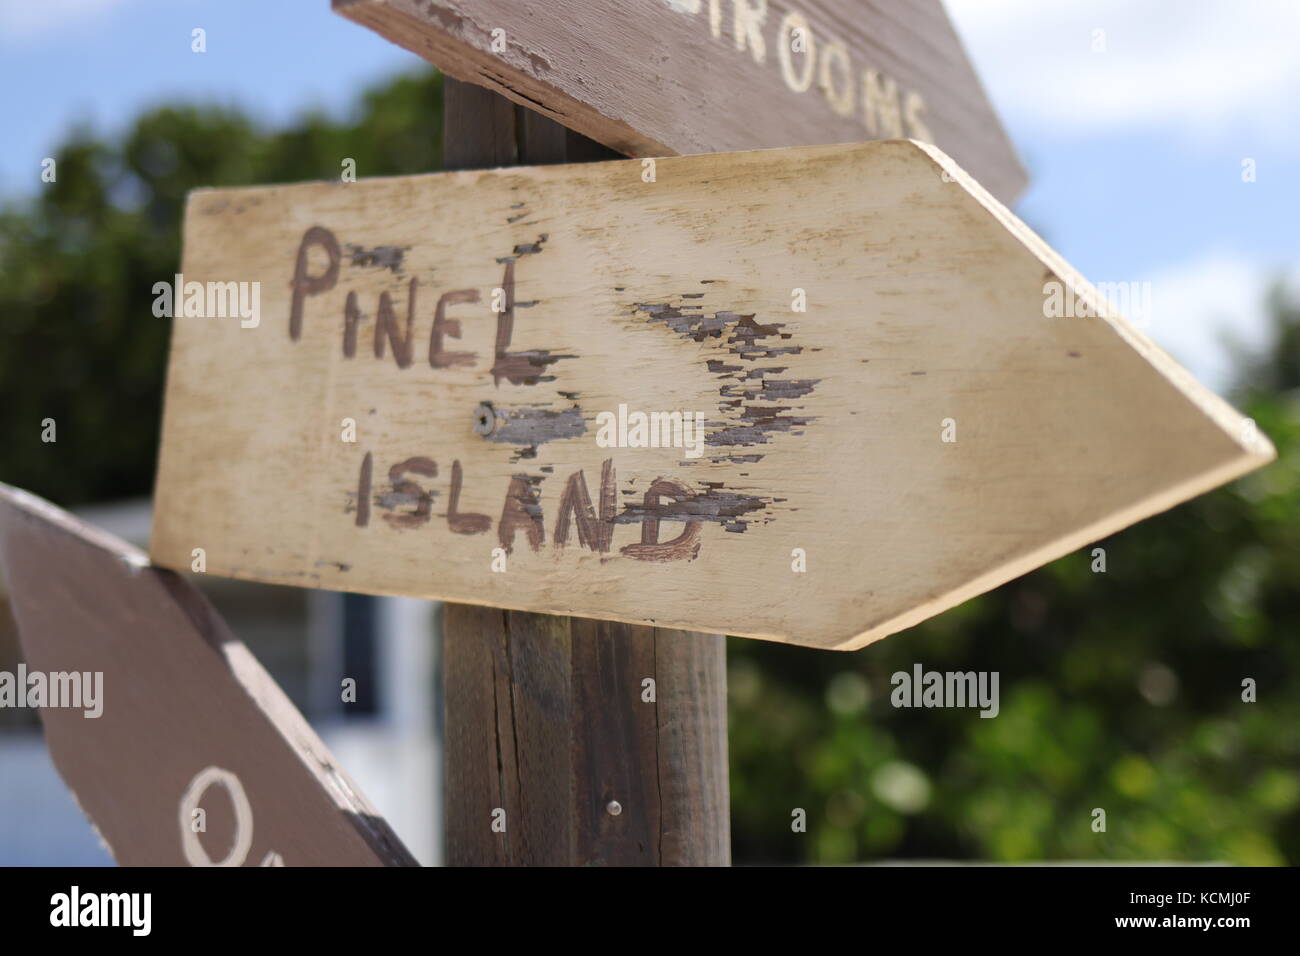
333, 0, 1024, 203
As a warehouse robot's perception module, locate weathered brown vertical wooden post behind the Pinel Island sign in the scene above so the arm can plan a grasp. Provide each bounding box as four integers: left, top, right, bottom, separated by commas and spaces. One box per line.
443, 77, 731, 866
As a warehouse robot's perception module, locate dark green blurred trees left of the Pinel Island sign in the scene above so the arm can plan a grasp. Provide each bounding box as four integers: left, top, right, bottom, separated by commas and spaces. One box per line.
0, 73, 442, 506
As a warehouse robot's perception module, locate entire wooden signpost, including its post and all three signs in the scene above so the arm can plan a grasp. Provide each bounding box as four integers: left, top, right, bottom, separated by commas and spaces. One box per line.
0, 0, 1273, 865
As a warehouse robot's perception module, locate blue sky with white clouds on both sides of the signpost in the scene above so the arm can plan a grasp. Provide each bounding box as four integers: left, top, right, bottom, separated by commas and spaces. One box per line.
0, 0, 1300, 388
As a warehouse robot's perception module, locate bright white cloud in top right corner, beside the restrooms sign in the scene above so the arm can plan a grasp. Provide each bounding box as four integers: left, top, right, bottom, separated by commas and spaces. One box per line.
946, 0, 1300, 144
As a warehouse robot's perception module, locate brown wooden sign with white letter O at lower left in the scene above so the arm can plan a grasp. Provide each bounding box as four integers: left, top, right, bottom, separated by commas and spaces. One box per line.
0, 485, 415, 866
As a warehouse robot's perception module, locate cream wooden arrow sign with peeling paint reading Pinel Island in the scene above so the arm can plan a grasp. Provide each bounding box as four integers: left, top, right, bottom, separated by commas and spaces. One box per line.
151, 142, 1273, 649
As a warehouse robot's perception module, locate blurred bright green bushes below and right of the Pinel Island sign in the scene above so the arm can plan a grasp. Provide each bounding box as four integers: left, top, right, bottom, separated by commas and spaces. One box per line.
728, 300, 1300, 865
